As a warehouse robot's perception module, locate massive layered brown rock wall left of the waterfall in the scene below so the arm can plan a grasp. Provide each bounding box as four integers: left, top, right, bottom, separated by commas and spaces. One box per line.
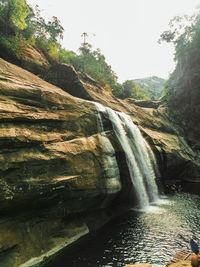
0, 60, 122, 267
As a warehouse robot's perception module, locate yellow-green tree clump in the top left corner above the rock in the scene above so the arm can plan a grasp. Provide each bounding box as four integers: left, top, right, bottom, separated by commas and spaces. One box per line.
0, 0, 67, 62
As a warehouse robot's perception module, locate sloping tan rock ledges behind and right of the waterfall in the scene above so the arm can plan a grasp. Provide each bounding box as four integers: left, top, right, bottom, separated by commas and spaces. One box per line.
43, 64, 200, 182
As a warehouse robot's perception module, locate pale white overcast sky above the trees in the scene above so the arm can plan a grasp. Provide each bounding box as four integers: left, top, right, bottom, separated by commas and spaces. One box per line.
27, 0, 200, 82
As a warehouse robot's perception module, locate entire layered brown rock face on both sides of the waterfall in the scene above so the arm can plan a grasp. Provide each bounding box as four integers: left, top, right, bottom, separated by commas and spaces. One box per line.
0, 59, 199, 267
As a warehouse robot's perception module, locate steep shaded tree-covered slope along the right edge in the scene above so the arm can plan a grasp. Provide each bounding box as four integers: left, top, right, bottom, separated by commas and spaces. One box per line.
161, 13, 200, 150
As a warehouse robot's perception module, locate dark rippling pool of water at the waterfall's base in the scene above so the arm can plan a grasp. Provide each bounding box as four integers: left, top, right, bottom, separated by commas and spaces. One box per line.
48, 193, 200, 267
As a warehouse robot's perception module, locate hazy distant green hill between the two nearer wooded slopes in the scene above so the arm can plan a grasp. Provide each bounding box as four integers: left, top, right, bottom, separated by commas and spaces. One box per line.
134, 76, 165, 100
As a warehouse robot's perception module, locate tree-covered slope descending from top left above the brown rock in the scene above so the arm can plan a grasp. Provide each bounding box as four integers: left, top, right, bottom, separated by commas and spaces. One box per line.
0, 0, 161, 99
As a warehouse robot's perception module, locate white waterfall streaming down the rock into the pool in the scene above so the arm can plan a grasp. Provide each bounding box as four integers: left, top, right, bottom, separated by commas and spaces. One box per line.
94, 103, 159, 209
